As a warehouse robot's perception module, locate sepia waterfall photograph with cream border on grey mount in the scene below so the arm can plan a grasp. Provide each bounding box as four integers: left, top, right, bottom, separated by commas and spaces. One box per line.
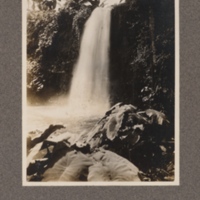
22, 0, 180, 186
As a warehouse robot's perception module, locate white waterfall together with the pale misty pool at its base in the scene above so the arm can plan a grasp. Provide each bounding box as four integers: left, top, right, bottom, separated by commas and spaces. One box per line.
27, 7, 111, 133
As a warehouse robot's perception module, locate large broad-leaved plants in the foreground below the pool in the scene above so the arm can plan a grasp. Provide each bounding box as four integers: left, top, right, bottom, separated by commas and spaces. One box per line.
27, 103, 174, 181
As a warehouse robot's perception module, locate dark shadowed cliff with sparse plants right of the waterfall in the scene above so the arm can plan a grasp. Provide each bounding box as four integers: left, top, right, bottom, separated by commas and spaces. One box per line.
110, 0, 174, 118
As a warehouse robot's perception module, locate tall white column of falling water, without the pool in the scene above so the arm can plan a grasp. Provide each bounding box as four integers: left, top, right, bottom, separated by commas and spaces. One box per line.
68, 7, 111, 115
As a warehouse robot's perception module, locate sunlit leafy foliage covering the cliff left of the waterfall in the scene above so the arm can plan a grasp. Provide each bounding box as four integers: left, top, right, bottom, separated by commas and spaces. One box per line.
27, 0, 94, 101
